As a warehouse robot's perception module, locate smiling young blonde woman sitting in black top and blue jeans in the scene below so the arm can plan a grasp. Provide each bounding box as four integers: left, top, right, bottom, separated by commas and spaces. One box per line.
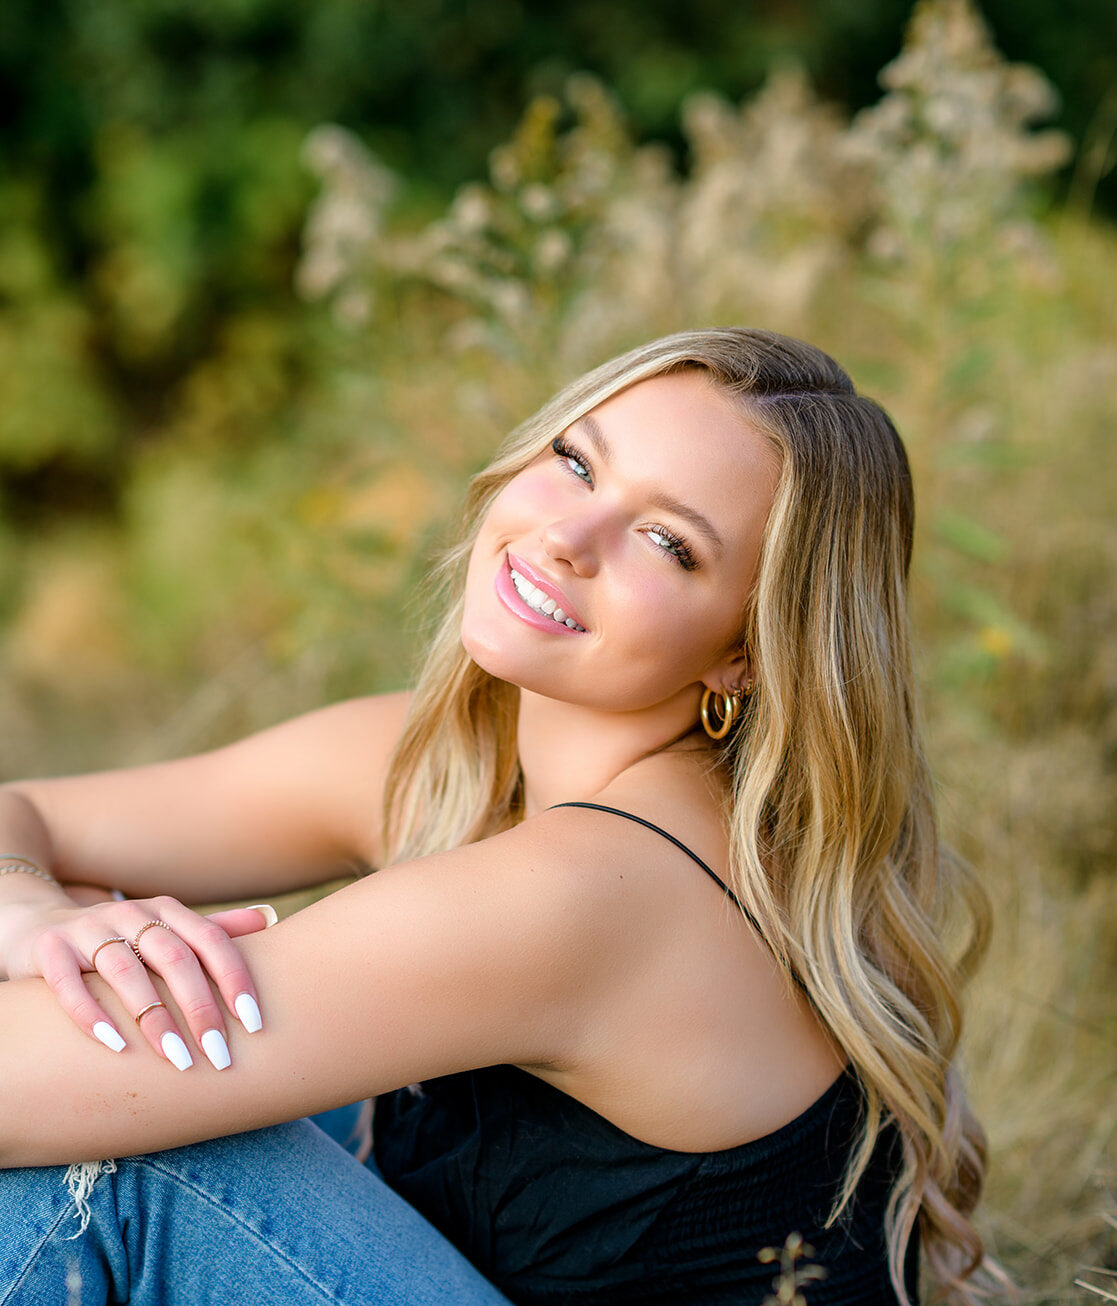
0, 329, 984, 1306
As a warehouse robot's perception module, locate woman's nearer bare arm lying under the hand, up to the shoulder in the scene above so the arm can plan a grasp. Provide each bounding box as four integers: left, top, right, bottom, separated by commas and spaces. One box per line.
0, 827, 610, 1165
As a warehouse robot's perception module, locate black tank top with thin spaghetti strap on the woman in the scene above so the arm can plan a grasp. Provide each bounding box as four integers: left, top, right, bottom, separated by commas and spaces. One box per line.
375, 803, 918, 1306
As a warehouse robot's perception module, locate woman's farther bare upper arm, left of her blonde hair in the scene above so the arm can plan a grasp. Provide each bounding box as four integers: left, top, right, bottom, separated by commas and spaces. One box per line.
5, 693, 409, 902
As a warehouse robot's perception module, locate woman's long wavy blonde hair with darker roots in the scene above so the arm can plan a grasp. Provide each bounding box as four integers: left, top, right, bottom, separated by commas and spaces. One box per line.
384, 328, 997, 1303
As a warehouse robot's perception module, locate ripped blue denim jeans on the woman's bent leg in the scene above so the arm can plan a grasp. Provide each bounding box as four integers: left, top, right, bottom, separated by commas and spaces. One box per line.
0, 1109, 508, 1306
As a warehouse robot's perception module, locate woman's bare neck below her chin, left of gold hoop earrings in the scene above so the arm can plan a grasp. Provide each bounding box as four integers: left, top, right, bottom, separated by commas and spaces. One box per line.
517, 688, 699, 816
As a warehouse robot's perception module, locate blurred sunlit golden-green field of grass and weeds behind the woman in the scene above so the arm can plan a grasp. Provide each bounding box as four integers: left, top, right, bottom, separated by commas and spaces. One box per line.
0, 0, 1117, 1303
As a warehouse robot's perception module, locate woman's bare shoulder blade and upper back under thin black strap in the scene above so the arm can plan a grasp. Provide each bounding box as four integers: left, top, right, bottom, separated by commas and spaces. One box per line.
514, 757, 844, 1151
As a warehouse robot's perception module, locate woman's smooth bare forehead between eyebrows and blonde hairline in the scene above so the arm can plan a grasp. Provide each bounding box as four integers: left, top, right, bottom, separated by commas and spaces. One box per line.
574, 368, 780, 543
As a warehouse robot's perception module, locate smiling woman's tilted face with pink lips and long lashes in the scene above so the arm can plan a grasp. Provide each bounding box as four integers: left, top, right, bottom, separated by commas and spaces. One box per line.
461, 371, 779, 712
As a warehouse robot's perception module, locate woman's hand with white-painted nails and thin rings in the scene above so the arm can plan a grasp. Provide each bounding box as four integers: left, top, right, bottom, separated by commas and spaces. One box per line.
8, 897, 274, 1070
